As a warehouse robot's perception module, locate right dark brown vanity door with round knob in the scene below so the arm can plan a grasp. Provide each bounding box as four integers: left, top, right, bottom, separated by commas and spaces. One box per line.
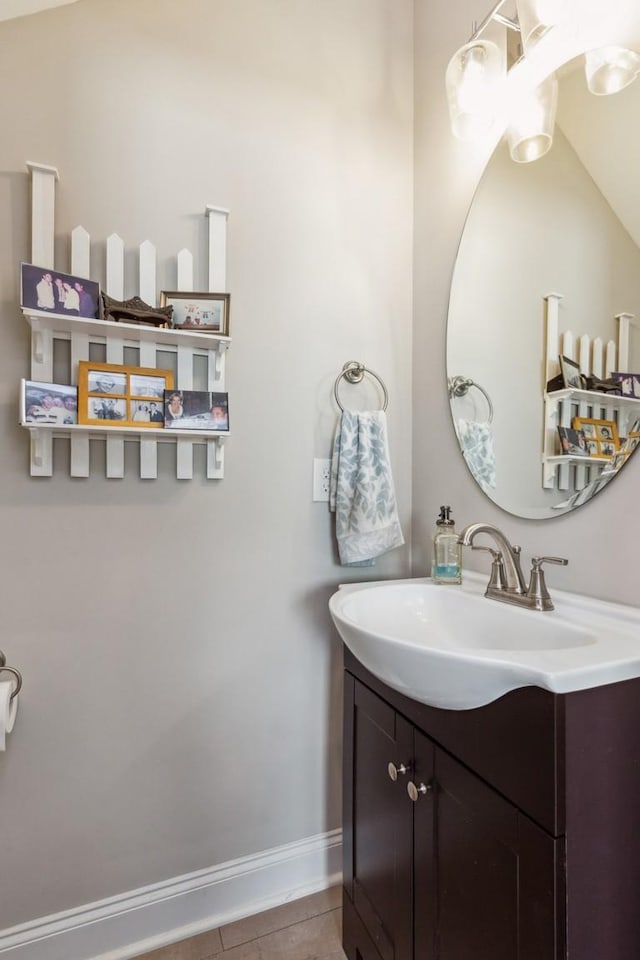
415, 741, 562, 960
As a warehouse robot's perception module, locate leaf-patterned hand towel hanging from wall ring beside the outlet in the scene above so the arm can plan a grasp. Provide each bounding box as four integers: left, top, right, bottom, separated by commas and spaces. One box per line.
329, 410, 404, 565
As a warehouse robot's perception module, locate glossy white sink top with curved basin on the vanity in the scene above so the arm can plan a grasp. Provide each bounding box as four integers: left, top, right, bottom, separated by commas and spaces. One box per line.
329, 574, 640, 710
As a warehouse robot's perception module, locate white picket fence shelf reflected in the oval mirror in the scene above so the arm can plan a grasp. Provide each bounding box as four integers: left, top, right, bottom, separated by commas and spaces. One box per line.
542, 293, 640, 491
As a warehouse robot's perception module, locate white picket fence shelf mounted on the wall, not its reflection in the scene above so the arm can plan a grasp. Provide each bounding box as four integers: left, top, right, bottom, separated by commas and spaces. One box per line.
21, 163, 231, 488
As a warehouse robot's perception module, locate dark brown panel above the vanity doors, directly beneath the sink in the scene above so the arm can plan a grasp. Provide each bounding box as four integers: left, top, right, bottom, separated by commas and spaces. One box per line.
344, 648, 565, 837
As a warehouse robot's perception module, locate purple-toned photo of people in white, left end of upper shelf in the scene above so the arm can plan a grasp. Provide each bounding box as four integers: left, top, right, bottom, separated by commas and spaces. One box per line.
20, 263, 100, 319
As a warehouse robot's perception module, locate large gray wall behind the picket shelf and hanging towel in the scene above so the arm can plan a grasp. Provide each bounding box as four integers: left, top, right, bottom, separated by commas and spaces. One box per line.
0, 0, 413, 928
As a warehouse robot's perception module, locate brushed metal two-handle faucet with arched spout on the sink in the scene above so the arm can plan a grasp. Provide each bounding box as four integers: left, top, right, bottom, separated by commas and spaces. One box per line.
458, 523, 569, 610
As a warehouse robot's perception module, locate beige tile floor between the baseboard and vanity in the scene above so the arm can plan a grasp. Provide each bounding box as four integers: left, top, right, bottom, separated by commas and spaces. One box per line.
137, 887, 345, 960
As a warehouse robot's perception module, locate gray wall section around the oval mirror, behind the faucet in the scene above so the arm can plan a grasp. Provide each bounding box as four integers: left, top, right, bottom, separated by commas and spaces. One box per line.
412, 0, 638, 603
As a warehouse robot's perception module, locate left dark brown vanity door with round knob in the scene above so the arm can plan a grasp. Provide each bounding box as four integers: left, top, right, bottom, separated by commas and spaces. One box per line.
344, 675, 413, 960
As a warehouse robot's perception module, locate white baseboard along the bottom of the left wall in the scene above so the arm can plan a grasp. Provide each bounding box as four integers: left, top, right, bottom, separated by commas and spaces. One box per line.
0, 830, 342, 960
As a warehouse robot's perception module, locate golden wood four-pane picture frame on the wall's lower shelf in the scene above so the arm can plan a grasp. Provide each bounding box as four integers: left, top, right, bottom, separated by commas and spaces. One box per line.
78, 360, 173, 428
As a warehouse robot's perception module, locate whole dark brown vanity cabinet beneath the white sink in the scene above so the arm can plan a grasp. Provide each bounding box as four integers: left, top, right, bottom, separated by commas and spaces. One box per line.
344, 648, 640, 960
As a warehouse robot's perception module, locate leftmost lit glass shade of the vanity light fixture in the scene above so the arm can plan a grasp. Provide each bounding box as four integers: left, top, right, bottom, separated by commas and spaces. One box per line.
445, 40, 504, 140
